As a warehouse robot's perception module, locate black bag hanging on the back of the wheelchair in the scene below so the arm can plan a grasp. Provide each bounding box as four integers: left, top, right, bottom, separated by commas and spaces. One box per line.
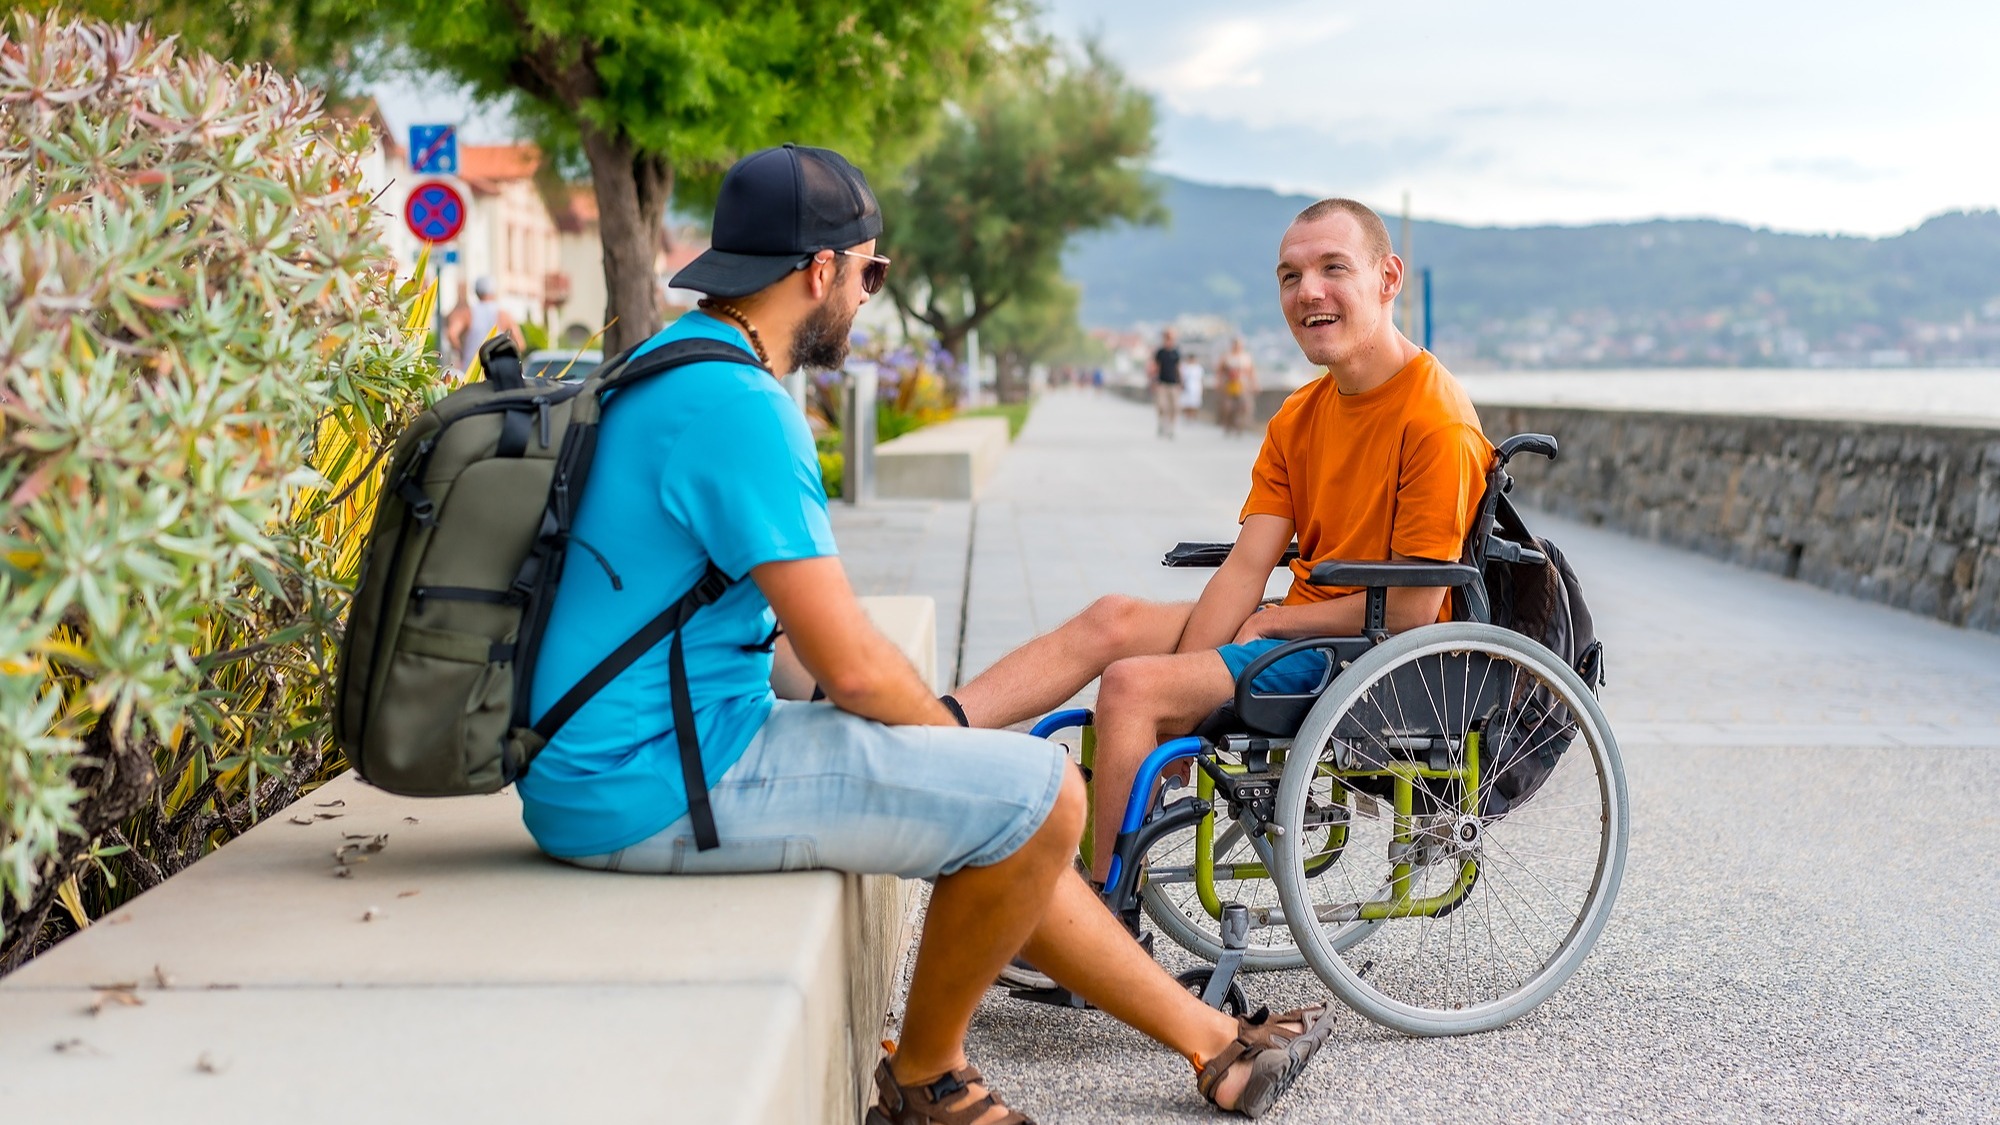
1480, 496, 1604, 817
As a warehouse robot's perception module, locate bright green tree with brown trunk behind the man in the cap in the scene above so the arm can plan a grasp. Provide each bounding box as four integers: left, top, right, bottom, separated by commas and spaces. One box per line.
354, 0, 1016, 348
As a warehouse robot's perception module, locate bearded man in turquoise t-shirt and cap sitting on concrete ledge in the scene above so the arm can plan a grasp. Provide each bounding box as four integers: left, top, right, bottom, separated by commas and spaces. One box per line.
520, 144, 1328, 1125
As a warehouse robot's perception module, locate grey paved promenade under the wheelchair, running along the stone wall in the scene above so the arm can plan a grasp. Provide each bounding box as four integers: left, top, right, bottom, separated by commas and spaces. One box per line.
936, 392, 2000, 1125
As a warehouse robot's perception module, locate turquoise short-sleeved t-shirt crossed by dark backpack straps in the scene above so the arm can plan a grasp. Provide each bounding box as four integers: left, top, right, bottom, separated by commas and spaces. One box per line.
518, 312, 836, 855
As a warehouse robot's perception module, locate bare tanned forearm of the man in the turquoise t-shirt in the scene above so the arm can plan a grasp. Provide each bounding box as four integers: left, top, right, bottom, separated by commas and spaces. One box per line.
750, 556, 958, 727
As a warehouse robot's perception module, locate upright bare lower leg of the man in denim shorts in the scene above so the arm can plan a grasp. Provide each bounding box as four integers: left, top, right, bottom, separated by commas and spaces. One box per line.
890, 771, 1088, 1119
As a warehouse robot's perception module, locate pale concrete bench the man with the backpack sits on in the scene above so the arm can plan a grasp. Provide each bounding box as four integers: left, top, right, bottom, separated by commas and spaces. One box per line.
0, 597, 936, 1125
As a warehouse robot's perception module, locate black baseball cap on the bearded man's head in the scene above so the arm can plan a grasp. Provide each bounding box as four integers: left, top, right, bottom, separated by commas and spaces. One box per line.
672, 144, 882, 296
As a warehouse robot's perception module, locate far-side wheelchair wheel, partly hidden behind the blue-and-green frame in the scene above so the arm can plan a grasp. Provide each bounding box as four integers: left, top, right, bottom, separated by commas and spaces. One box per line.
1140, 779, 1376, 973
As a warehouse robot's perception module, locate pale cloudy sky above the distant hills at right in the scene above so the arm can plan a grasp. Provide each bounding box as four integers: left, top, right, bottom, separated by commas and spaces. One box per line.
1048, 0, 2000, 234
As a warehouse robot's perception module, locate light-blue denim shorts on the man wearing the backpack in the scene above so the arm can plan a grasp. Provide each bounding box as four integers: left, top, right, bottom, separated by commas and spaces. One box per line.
564, 699, 1070, 879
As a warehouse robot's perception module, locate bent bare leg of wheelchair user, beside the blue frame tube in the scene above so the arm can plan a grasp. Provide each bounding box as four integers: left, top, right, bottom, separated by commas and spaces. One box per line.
1088, 651, 1236, 876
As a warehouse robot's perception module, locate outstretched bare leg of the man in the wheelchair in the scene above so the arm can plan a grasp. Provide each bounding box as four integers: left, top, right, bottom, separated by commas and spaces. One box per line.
952, 595, 1194, 727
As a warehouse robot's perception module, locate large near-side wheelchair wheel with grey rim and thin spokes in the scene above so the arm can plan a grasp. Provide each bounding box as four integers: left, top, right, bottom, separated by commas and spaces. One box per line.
1274, 623, 1626, 1035
